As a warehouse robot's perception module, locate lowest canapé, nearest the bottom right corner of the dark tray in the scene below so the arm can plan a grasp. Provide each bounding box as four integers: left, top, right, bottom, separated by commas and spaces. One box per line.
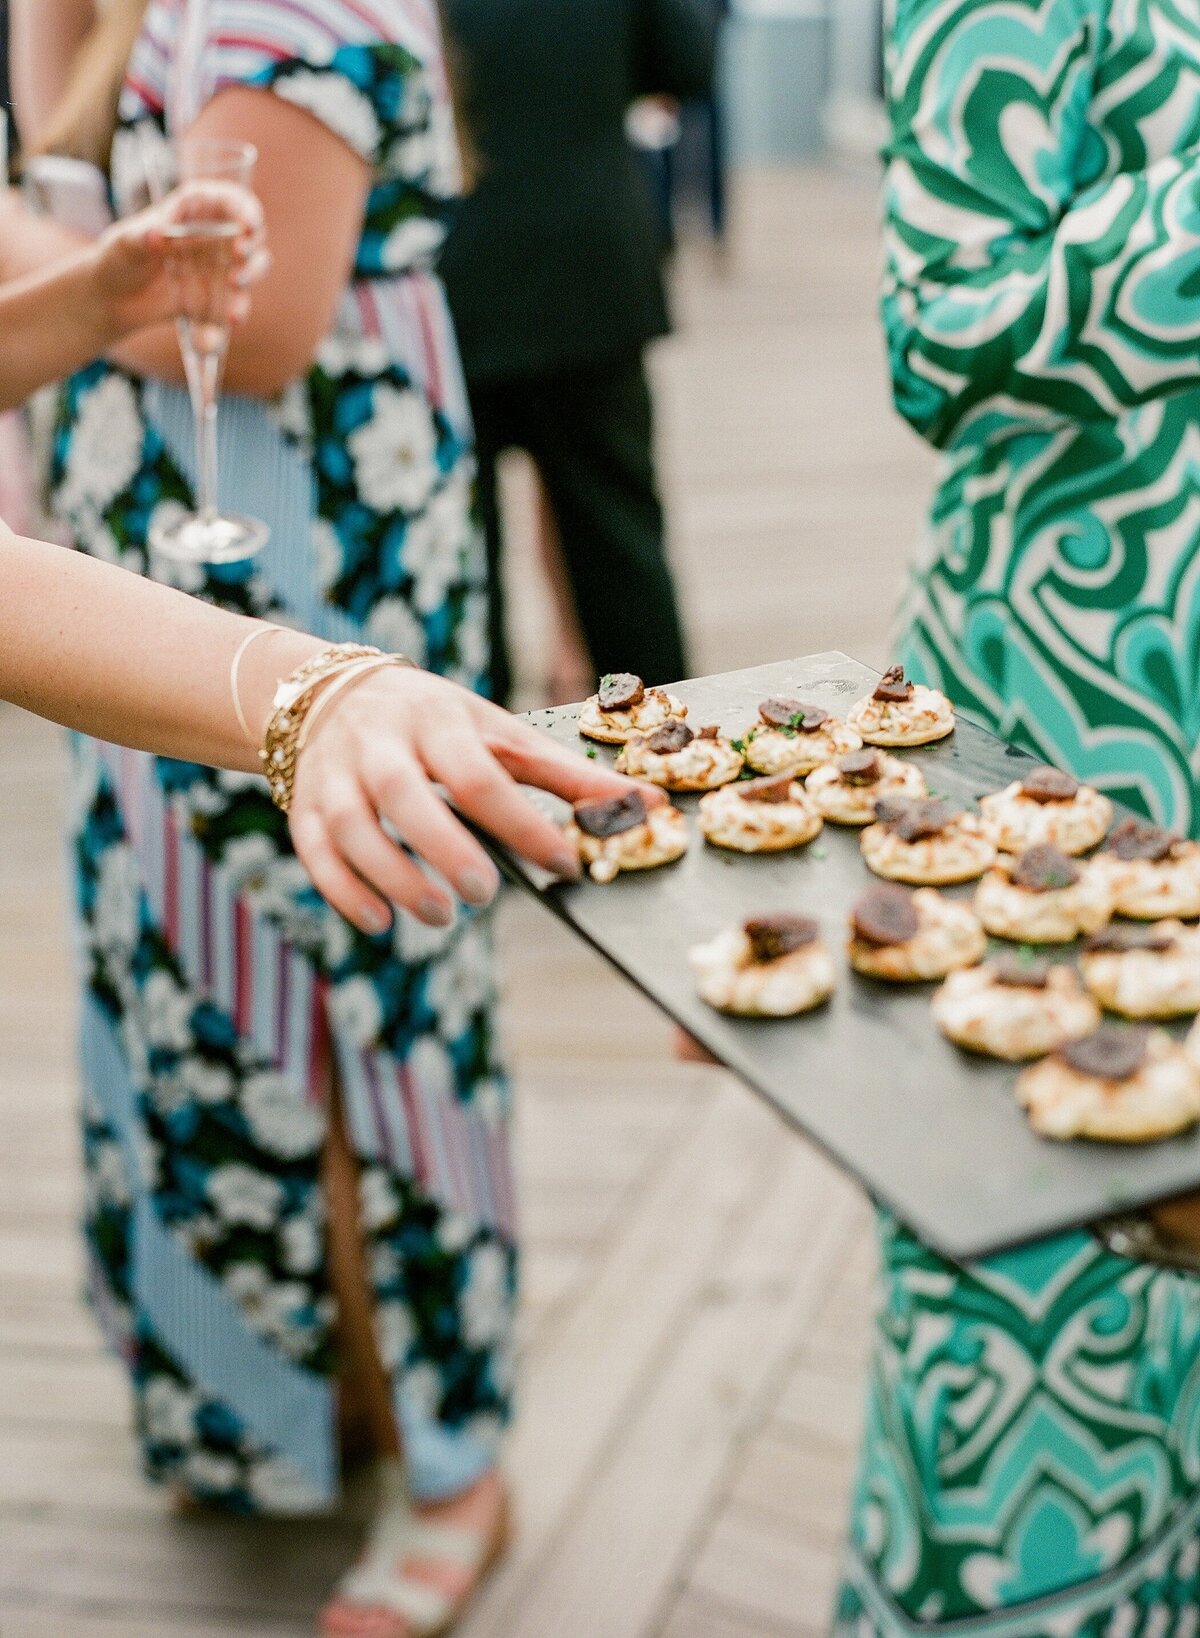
1017, 1024, 1200, 1143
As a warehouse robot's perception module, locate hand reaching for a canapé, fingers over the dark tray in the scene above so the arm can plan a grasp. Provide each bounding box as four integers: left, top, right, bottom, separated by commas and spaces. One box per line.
291, 668, 651, 934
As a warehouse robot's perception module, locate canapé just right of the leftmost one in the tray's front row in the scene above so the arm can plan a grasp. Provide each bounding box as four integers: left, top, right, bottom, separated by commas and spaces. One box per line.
848, 885, 987, 983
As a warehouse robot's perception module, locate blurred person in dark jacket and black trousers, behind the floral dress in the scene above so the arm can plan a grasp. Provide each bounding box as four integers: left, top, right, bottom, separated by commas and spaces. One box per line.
440, 0, 715, 699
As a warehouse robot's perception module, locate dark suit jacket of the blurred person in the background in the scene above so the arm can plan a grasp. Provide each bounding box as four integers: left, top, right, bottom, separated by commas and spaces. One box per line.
440, 0, 715, 382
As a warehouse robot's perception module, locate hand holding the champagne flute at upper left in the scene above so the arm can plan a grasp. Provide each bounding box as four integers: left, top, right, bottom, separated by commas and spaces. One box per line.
92, 182, 270, 339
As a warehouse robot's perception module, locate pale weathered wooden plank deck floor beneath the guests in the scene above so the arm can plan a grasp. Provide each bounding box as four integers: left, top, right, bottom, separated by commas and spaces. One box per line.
0, 172, 927, 1638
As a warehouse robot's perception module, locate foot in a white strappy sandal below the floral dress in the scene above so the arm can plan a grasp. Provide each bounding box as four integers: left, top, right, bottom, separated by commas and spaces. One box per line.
321, 1461, 508, 1638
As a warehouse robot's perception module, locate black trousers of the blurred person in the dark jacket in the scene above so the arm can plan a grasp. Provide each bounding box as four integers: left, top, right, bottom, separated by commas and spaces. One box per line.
471, 351, 688, 701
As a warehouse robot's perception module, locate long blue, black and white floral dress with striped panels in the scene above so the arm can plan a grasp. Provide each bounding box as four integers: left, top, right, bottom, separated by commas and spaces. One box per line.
49, 0, 514, 1512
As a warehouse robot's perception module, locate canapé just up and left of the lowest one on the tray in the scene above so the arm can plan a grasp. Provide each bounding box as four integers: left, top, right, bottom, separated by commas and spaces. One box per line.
930, 955, 1100, 1063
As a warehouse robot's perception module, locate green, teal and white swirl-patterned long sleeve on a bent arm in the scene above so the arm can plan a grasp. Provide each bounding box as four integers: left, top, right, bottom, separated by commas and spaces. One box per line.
882, 0, 1200, 447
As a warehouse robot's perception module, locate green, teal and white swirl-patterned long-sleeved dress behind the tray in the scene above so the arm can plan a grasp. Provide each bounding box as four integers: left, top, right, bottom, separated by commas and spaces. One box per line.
837, 0, 1200, 1638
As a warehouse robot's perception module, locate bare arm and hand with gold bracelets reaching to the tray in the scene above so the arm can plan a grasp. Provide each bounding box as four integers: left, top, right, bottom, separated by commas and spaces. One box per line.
0, 526, 629, 932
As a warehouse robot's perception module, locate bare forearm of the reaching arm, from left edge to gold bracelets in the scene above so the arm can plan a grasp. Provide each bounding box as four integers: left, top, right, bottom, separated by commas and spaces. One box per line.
0, 529, 323, 771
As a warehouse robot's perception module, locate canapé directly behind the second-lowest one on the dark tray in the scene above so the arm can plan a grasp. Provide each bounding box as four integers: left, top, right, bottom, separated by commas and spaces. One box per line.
976, 842, 1113, 943
